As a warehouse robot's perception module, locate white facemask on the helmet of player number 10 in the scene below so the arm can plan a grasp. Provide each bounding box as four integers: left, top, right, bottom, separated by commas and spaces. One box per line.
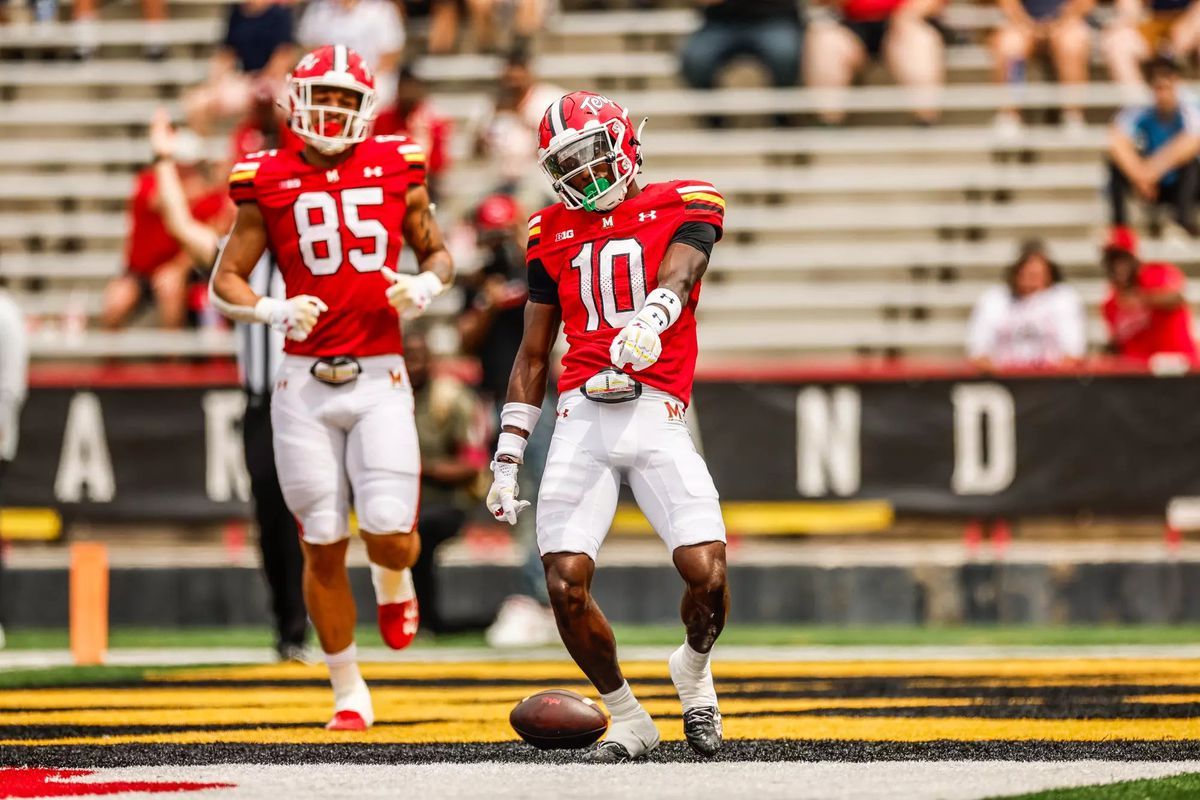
538, 120, 637, 212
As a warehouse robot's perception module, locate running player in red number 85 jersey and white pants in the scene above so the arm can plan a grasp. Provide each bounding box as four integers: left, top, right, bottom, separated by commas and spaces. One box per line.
211, 46, 454, 730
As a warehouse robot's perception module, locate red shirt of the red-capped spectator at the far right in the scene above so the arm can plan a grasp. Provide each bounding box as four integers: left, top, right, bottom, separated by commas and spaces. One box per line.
1100, 263, 1196, 361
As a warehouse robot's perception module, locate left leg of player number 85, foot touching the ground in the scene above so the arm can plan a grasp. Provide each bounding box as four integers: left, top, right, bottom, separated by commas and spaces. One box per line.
271, 371, 374, 730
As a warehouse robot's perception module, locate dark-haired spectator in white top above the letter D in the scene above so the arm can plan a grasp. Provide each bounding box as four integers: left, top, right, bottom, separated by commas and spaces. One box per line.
967, 241, 1087, 369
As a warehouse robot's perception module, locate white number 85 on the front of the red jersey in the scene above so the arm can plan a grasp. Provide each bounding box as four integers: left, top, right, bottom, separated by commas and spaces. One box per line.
293, 186, 388, 275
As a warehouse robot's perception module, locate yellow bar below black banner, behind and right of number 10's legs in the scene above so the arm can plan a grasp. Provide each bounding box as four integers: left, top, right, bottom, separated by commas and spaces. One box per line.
612, 500, 895, 535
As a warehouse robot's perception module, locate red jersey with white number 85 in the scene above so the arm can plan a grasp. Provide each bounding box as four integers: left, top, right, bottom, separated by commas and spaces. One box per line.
229, 136, 425, 357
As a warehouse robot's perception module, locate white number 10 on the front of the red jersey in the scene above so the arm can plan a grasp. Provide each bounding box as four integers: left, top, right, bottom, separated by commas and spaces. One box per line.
571, 239, 646, 331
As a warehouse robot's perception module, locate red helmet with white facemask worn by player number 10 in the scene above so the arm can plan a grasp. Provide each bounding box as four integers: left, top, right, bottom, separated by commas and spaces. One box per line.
538, 91, 646, 211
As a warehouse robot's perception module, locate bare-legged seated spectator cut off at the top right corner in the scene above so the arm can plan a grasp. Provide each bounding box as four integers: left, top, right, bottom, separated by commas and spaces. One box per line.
1100, 0, 1200, 86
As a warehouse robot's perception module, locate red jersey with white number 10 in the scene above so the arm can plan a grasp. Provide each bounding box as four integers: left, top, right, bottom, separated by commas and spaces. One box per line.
526, 180, 725, 403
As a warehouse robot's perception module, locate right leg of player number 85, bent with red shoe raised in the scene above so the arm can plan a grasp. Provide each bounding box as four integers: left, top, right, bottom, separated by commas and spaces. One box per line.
346, 356, 421, 650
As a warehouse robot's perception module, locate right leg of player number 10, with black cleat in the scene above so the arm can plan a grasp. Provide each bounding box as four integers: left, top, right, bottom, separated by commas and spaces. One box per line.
629, 393, 730, 756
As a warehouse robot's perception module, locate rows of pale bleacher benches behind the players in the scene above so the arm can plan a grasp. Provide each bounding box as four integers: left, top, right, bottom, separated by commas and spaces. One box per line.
0, 0, 1200, 360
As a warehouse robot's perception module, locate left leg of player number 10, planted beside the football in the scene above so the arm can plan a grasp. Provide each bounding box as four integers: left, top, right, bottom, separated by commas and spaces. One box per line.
538, 395, 659, 763
